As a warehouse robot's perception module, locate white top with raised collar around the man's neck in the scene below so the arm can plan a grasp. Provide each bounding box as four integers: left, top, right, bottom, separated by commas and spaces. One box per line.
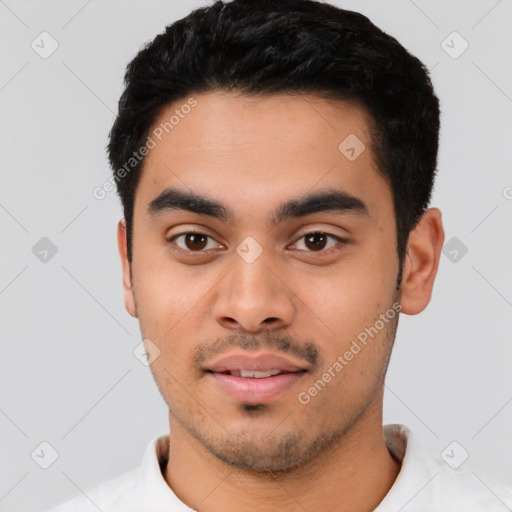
51, 424, 512, 512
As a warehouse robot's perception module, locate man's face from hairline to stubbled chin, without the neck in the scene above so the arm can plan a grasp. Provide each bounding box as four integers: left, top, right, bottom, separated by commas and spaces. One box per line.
120, 92, 400, 471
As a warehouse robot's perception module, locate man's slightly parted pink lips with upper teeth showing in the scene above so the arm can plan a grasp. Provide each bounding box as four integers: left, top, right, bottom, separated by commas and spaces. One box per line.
205, 354, 308, 405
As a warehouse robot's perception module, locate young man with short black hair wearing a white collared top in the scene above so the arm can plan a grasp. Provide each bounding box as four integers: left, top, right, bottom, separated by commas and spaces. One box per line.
50, 0, 512, 512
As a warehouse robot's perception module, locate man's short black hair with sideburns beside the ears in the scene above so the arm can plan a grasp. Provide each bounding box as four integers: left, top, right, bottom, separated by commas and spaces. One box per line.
108, 0, 440, 288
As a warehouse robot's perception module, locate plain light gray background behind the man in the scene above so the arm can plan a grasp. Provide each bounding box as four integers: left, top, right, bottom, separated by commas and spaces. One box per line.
0, 0, 512, 512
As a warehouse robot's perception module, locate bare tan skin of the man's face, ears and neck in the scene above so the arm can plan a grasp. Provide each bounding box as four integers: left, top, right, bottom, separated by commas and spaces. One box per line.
118, 92, 444, 512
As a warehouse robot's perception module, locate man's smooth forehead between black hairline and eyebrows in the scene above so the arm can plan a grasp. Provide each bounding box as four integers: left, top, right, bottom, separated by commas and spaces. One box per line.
136, 92, 392, 222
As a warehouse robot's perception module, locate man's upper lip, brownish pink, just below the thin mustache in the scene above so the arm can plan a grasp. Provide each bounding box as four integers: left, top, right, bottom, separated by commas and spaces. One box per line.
205, 353, 307, 373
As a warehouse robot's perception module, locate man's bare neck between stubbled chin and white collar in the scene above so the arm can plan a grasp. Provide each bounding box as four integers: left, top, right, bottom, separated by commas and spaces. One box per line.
164, 406, 400, 512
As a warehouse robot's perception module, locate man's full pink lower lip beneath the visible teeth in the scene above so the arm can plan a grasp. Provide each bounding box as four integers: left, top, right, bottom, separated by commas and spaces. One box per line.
209, 371, 306, 404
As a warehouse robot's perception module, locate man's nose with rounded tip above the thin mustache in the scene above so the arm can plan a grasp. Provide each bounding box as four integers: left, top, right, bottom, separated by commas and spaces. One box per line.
213, 250, 295, 333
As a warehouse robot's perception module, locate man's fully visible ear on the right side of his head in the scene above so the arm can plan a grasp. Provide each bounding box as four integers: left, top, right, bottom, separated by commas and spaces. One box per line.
400, 208, 444, 315
